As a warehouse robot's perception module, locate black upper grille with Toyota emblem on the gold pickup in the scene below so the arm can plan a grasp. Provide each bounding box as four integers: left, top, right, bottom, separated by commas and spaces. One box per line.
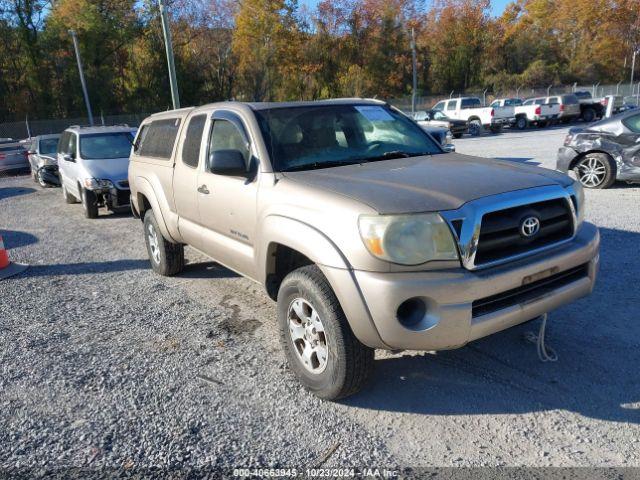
475, 198, 574, 266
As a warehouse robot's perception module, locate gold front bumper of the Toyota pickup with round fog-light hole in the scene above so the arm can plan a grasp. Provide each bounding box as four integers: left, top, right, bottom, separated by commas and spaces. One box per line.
348, 223, 600, 350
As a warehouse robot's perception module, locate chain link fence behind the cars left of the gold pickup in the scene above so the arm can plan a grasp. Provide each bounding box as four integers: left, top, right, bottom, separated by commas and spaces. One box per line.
0, 113, 149, 140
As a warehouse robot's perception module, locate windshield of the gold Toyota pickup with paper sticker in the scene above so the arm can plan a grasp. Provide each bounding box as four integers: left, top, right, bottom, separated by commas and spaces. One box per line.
256, 104, 442, 171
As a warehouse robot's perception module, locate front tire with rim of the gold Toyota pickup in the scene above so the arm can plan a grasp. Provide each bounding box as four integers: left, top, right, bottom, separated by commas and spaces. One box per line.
278, 265, 374, 400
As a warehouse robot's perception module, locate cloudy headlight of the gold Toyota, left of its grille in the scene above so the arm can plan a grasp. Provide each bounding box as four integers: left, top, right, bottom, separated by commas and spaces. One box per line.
359, 213, 458, 265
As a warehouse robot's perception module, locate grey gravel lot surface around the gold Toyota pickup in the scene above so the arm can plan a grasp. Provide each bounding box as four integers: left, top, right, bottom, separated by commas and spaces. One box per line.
0, 128, 640, 475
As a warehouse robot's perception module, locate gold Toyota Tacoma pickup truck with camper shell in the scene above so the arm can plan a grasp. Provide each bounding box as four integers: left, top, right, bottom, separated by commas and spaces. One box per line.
129, 99, 599, 399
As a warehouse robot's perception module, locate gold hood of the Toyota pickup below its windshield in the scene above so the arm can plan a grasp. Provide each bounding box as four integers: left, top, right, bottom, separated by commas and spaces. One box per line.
283, 153, 572, 214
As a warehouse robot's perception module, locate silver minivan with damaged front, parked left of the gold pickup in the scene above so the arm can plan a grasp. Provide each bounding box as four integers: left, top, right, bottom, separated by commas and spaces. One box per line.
58, 126, 136, 218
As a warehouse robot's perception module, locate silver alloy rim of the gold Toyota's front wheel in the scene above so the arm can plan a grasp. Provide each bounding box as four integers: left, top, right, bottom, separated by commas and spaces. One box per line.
287, 298, 329, 375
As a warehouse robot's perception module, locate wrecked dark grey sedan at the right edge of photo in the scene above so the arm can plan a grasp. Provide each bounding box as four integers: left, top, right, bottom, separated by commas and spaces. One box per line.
556, 110, 640, 188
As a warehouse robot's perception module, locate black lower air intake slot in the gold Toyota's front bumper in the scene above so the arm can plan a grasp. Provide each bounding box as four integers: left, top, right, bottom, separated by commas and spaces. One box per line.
471, 263, 589, 318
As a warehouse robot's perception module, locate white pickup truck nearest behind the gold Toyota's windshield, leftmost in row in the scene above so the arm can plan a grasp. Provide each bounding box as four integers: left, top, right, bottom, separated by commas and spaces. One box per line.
433, 97, 514, 136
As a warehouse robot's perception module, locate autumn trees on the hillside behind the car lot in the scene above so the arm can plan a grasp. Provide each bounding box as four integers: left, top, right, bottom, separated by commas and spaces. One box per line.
0, 0, 640, 121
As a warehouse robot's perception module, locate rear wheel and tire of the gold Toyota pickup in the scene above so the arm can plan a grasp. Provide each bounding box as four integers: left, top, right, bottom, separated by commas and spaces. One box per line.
144, 210, 184, 277
